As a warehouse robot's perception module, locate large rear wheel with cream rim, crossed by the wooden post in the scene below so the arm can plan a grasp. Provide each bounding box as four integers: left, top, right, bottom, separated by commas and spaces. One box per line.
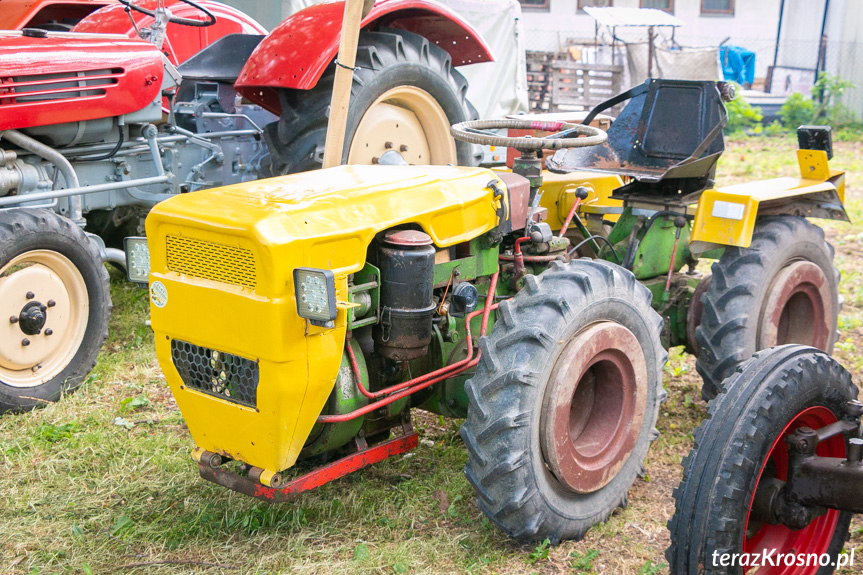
264, 30, 477, 175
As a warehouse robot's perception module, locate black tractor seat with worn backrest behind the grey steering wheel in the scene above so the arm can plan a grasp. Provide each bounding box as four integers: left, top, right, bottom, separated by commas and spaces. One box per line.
546, 79, 728, 183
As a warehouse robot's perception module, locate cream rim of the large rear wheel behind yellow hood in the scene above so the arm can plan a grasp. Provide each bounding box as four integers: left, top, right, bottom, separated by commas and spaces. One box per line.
348, 86, 458, 165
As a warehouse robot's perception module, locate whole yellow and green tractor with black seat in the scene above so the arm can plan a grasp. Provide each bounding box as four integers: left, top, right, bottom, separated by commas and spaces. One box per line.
130, 80, 846, 542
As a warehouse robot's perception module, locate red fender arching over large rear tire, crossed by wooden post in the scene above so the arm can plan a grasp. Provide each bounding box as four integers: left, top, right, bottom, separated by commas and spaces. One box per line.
234, 0, 494, 114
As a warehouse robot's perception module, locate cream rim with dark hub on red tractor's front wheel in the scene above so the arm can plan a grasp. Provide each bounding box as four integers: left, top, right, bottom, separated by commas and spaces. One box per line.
0, 250, 90, 387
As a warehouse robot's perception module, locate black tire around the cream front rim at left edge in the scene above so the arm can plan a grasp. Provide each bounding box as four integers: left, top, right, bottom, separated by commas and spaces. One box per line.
0, 210, 111, 413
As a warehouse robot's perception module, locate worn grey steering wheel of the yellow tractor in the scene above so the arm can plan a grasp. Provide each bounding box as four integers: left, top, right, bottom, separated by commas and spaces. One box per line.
450, 119, 608, 152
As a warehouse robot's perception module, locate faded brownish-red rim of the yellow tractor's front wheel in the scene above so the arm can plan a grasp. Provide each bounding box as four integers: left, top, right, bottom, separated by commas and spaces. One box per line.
541, 322, 647, 493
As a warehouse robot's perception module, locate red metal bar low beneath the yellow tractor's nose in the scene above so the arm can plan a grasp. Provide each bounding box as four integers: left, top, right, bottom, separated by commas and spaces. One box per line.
198, 424, 419, 503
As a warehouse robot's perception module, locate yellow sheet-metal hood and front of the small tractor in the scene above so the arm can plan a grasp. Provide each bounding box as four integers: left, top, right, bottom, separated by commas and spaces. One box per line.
147, 166, 504, 471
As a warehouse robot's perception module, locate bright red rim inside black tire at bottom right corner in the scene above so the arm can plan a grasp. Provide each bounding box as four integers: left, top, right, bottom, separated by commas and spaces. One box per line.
743, 406, 845, 575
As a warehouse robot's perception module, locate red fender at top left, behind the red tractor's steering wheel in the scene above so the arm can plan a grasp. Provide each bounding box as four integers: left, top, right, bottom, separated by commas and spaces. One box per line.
72, 0, 267, 65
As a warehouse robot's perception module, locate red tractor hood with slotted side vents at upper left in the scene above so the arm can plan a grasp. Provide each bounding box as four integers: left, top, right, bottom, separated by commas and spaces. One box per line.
0, 31, 163, 130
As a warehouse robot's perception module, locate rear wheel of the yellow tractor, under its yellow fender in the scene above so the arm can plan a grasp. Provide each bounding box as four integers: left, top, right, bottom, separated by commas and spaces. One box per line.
696, 216, 839, 401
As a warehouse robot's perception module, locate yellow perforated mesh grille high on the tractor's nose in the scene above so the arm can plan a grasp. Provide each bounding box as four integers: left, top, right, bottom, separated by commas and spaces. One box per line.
167, 236, 257, 290
